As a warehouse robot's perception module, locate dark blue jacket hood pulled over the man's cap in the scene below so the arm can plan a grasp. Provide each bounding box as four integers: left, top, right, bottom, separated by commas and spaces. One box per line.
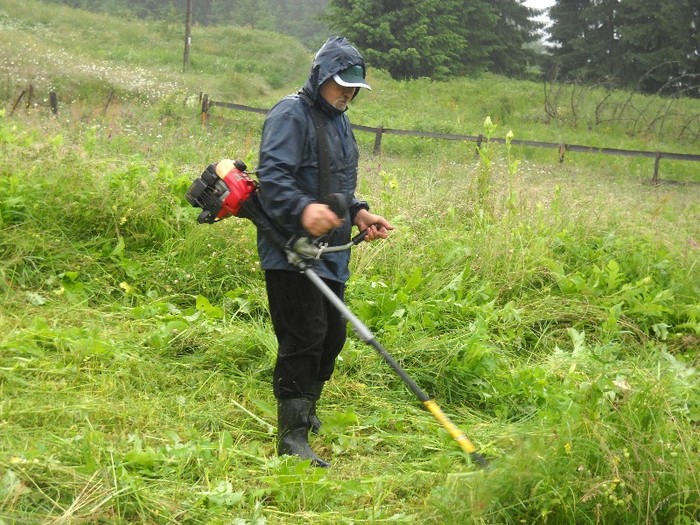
301, 36, 366, 104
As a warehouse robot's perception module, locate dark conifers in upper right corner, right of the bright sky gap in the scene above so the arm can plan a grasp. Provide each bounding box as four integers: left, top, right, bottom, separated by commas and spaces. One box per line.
549, 0, 700, 97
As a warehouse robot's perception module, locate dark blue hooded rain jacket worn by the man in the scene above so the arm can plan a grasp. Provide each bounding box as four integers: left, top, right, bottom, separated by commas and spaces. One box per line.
256, 37, 369, 283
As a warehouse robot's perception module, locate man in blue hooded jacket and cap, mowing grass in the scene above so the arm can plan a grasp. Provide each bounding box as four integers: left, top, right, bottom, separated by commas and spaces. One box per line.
257, 37, 393, 467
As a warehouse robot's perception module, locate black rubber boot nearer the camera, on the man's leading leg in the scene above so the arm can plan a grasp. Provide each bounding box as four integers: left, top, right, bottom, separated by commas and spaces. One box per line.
277, 398, 330, 467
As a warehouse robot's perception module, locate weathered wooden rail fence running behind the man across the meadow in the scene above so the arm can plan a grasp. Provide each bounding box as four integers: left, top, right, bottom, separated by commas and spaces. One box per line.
201, 94, 700, 184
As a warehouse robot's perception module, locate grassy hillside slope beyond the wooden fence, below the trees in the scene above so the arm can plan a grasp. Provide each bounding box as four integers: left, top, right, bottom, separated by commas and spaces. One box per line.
0, 0, 700, 169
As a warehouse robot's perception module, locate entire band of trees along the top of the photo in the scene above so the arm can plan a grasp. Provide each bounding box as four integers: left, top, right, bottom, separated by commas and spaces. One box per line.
39, 0, 700, 97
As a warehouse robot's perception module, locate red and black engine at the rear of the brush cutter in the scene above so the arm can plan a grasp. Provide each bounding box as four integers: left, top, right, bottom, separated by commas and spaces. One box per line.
186, 160, 258, 224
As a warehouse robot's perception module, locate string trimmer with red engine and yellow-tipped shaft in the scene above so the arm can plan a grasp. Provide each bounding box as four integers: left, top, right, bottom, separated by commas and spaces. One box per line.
187, 160, 487, 467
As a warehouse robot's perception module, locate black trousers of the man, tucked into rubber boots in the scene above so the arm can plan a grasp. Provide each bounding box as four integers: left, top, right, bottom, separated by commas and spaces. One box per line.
265, 270, 347, 399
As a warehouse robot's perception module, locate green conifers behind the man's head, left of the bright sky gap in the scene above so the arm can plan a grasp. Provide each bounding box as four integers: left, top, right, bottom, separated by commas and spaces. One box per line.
325, 0, 538, 80
